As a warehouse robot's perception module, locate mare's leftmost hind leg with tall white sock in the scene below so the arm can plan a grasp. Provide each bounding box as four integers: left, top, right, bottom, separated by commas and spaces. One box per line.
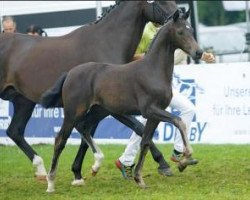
7, 95, 47, 180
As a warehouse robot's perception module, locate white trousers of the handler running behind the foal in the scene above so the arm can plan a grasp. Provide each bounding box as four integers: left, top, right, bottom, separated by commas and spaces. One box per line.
119, 89, 195, 166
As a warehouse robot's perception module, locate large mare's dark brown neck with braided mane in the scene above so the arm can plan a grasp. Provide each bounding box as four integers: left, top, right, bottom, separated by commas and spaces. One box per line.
74, 1, 147, 63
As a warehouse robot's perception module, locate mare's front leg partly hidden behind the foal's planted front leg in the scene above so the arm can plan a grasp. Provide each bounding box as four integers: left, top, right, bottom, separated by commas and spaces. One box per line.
112, 114, 173, 176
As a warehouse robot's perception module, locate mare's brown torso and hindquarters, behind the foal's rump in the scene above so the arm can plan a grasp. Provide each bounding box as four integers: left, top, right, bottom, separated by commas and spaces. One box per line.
0, 33, 83, 102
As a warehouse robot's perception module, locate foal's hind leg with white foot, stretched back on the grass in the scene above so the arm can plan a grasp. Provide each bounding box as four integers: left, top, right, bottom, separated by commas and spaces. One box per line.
47, 116, 74, 192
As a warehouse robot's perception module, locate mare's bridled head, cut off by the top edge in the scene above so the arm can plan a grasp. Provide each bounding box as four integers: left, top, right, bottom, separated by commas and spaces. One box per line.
139, 1, 177, 24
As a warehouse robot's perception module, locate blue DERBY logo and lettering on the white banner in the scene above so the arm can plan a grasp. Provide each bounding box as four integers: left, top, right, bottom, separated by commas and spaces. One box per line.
164, 74, 207, 142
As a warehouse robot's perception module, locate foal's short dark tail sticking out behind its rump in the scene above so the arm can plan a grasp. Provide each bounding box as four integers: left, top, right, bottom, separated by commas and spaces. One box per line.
40, 73, 67, 108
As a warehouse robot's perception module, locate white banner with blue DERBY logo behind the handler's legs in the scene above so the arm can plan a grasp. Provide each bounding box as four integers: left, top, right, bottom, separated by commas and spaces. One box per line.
159, 62, 250, 144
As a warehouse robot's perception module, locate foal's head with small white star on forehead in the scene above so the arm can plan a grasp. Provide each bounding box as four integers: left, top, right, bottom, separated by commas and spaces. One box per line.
169, 10, 203, 59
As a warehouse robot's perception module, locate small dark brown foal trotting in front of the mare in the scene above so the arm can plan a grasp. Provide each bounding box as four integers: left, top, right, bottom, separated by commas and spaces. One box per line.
41, 10, 202, 192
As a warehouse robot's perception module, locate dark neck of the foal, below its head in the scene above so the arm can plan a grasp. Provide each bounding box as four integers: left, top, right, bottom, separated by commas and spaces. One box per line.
145, 26, 176, 82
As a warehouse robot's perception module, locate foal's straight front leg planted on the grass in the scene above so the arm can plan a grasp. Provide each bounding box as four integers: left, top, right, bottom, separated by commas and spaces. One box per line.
134, 119, 159, 188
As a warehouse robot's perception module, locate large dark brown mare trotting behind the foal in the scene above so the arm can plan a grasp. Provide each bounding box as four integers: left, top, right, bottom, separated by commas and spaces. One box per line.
0, 1, 176, 183
